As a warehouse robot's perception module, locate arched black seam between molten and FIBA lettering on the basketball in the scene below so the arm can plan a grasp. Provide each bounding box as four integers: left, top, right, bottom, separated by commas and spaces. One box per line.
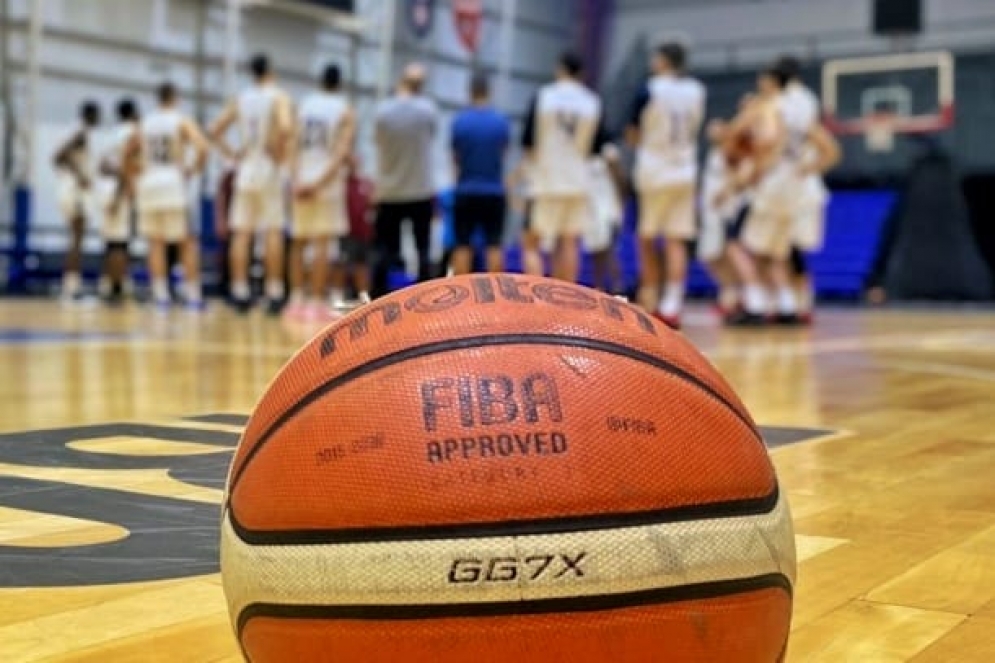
229, 334, 763, 494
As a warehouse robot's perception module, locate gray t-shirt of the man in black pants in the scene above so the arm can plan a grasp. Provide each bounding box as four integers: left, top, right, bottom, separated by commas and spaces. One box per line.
375, 96, 438, 203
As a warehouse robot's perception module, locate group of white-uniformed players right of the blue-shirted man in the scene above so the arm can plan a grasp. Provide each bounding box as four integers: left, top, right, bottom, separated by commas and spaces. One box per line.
522, 44, 840, 328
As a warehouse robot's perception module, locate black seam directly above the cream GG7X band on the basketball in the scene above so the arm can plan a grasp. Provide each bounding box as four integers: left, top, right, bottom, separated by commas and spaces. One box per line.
228, 484, 780, 546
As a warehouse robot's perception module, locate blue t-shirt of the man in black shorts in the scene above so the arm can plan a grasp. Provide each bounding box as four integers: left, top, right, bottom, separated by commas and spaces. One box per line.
452, 106, 511, 195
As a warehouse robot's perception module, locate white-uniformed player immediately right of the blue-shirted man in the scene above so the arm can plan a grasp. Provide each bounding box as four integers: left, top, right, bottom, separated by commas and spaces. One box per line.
522, 53, 606, 282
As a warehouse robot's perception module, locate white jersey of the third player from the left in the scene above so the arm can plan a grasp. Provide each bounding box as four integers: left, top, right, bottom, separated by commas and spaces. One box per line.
138, 108, 186, 210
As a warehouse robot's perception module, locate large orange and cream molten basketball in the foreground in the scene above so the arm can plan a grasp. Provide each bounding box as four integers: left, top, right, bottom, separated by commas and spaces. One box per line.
221, 274, 795, 663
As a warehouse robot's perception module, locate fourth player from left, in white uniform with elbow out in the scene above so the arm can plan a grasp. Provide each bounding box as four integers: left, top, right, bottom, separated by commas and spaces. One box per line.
210, 55, 293, 315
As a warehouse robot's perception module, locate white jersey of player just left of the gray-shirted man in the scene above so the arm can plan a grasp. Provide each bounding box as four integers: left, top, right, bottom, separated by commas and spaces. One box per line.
297, 92, 349, 197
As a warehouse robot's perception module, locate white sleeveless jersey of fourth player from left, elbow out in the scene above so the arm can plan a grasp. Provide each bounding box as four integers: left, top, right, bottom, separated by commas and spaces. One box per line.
235, 85, 284, 191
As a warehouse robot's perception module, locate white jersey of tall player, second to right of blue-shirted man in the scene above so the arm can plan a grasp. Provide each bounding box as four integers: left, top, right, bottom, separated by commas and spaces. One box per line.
631, 75, 705, 191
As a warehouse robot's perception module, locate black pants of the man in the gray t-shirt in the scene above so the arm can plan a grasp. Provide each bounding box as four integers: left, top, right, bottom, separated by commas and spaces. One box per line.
370, 199, 435, 297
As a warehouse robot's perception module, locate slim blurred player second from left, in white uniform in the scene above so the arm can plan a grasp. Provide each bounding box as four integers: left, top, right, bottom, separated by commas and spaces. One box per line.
98, 99, 139, 303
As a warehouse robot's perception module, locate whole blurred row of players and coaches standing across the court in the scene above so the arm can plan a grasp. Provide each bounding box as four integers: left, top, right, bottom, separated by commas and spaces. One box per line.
56, 44, 840, 328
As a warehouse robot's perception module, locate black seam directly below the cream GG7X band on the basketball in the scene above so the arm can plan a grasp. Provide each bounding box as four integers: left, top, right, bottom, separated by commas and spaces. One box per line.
237, 573, 792, 636
